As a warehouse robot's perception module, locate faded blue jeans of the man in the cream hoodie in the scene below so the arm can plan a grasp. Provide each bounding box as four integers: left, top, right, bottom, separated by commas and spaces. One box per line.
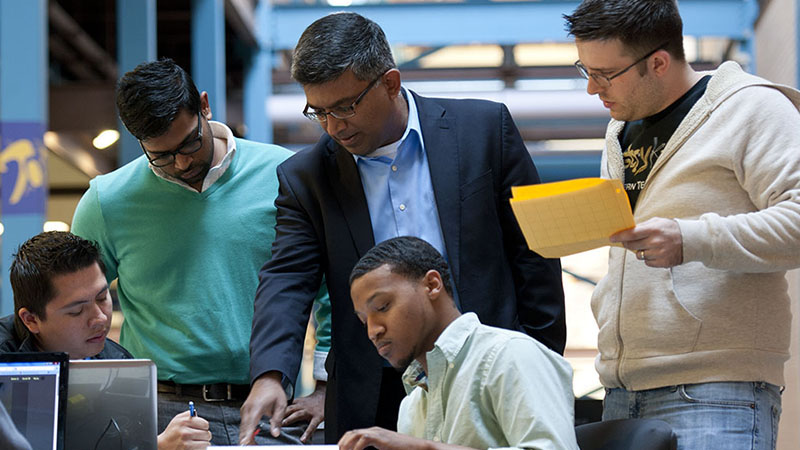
603, 382, 781, 450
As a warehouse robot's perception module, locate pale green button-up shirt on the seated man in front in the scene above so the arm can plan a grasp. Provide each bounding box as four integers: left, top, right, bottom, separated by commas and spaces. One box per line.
397, 313, 578, 450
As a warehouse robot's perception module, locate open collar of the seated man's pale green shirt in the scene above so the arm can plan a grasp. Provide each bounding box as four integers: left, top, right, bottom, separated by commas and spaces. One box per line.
403, 313, 480, 392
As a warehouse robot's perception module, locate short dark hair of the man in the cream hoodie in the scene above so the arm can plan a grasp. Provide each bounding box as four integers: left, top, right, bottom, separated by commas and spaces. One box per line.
564, 0, 686, 61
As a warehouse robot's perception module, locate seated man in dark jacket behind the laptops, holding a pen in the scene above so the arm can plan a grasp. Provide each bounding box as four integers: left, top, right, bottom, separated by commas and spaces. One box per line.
0, 231, 211, 450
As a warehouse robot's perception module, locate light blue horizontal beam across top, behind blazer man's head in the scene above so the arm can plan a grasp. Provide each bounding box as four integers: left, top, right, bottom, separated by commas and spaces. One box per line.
271, 0, 756, 49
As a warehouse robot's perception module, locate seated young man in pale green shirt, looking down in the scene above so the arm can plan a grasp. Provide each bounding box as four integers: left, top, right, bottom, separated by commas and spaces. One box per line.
339, 236, 578, 450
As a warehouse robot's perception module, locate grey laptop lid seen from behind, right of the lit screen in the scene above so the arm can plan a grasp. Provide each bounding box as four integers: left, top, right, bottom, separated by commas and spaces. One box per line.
65, 359, 158, 450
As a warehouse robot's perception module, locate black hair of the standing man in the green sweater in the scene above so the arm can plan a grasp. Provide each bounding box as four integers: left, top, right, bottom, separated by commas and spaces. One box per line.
117, 58, 200, 141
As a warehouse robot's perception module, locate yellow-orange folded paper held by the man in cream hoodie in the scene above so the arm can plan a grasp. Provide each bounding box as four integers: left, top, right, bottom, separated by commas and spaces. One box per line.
511, 178, 635, 258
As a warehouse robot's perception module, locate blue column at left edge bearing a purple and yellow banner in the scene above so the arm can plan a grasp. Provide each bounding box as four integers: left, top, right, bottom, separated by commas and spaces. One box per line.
0, 0, 48, 316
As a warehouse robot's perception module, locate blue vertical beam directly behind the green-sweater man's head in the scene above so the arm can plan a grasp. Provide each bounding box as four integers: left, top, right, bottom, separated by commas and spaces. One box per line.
117, 0, 156, 166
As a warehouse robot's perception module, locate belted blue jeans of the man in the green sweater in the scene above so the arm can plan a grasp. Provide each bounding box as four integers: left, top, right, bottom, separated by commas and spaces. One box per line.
158, 392, 308, 445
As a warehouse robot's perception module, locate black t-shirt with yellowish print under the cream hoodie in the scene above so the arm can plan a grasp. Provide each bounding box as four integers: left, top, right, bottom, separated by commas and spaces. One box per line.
619, 75, 711, 209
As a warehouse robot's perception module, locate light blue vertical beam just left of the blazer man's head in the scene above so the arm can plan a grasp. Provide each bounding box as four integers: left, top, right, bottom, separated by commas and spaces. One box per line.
243, 0, 272, 143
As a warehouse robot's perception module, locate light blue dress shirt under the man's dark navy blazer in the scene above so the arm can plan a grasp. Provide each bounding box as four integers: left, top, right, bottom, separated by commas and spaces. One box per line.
355, 88, 447, 259
